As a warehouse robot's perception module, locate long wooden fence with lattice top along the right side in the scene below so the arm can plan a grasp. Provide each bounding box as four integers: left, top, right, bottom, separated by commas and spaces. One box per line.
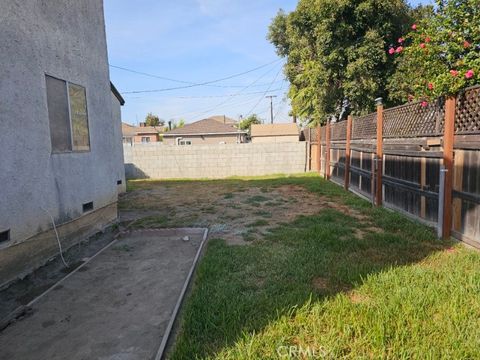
308, 86, 480, 247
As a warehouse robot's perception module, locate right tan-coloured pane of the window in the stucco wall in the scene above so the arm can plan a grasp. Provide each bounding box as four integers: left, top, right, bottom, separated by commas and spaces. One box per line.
68, 84, 90, 151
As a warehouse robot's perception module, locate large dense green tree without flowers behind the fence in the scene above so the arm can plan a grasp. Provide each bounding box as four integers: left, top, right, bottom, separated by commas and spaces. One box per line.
268, 0, 412, 123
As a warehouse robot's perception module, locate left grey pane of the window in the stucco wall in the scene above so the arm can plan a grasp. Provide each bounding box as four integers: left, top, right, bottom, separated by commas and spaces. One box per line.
46, 76, 72, 152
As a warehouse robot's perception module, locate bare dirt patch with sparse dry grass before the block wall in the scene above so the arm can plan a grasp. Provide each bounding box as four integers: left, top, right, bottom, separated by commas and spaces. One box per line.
120, 181, 366, 245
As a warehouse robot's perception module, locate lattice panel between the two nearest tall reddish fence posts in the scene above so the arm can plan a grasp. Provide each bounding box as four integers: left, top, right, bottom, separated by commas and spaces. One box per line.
383, 100, 445, 138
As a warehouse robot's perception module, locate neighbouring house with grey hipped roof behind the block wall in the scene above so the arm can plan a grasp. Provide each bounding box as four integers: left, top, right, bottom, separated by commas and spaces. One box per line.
163, 118, 247, 145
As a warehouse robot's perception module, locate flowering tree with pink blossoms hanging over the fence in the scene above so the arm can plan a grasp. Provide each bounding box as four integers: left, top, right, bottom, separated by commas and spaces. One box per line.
389, 0, 480, 105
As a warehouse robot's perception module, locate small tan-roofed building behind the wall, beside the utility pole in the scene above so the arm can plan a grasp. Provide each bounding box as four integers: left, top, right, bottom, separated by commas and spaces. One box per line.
250, 124, 300, 143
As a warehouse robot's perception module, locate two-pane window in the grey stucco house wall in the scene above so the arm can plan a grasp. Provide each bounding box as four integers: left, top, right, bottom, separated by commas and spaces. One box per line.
46, 75, 90, 153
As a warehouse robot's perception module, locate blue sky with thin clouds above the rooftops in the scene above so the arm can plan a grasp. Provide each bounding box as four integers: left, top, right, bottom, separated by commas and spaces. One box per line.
104, 0, 430, 124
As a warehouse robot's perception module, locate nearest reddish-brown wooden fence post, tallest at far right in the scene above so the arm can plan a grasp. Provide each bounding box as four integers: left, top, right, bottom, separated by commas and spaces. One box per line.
439, 97, 456, 238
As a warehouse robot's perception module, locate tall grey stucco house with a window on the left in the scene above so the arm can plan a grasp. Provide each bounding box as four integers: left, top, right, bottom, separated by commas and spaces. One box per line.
0, 0, 125, 287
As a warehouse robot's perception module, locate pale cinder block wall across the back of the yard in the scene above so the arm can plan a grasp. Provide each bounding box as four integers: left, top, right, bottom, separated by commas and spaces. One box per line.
124, 142, 307, 179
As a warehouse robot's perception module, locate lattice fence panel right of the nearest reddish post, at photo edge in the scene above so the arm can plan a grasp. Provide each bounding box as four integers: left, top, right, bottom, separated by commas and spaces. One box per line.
455, 86, 480, 134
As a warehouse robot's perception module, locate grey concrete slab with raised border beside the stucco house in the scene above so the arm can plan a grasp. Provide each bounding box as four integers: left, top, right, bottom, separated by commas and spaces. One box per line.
0, 229, 206, 360
